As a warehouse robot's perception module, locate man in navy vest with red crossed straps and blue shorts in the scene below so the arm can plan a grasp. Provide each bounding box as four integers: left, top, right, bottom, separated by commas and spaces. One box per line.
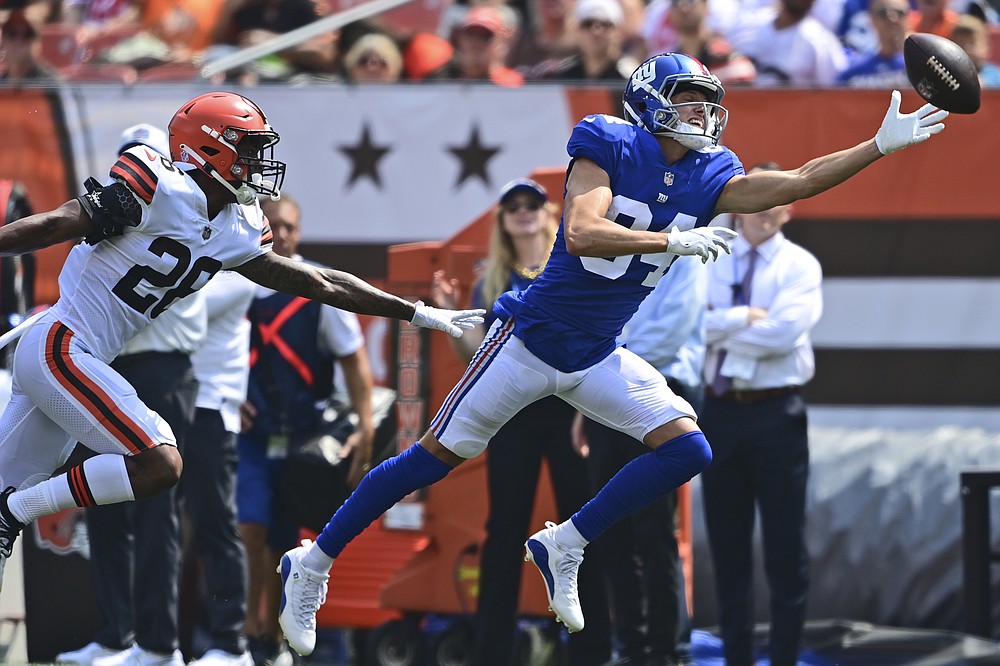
236, 193, 375, 666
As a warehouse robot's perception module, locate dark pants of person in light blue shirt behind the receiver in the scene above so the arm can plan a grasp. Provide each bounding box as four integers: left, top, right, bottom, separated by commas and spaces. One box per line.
585, 376, 701, 664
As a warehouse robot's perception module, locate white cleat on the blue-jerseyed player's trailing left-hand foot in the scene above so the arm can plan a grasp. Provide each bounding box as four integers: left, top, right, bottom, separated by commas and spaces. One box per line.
278, 539, 330, 657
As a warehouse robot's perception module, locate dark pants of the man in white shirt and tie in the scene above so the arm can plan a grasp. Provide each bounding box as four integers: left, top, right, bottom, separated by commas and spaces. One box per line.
699, 392, 809, 664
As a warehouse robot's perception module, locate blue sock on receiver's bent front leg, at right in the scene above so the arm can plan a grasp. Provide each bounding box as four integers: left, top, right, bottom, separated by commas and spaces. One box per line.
570, 430, 712, 542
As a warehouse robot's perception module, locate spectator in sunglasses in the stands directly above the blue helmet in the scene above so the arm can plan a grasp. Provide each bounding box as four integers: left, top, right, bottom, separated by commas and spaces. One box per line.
644, 0, 757, 85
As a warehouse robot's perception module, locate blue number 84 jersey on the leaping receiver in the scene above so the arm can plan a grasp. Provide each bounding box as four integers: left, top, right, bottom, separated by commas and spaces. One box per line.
494, 115, 743, 372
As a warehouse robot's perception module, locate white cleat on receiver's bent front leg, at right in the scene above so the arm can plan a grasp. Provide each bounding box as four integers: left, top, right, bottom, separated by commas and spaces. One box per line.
524, 522, 583, 633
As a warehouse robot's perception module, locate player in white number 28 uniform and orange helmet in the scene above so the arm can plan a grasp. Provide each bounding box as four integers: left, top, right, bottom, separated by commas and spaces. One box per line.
0, 92, 483, 588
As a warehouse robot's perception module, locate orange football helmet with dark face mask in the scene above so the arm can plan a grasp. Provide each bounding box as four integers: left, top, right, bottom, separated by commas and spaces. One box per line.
167, 92, 285, 205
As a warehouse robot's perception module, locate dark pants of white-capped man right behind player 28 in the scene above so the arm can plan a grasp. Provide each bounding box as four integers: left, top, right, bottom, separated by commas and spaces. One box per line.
86, 352, 198, 652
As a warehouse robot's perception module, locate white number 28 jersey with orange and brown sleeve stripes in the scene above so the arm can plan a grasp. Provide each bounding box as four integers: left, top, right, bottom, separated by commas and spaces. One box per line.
52, 146, 272, 363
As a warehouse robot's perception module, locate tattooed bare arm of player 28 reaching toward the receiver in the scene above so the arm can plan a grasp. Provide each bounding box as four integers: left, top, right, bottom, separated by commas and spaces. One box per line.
234, 252, 416, 321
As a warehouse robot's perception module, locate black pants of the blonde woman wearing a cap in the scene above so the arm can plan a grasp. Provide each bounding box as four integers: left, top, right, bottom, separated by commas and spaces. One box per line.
472, 396, 611, 666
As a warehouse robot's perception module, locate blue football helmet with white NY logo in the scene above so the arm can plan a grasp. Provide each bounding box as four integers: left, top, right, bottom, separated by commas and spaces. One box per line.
622, 53, 729, 150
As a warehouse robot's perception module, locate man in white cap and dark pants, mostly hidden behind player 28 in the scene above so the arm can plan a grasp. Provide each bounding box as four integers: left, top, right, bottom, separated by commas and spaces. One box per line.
56, 125, 206, 666
